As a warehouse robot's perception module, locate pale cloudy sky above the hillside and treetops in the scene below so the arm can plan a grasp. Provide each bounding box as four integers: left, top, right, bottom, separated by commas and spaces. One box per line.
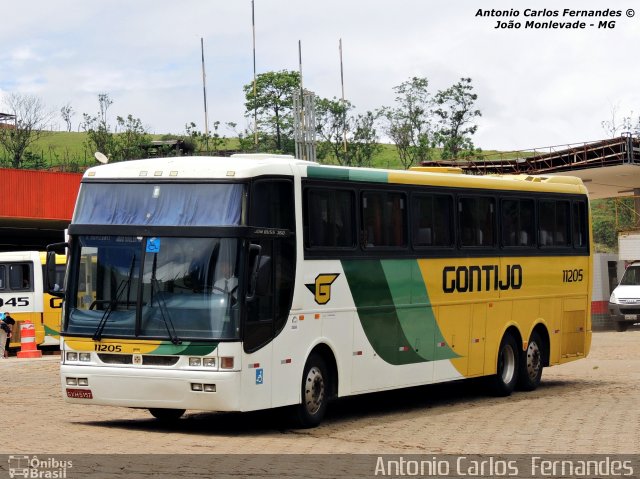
0, 0, 640, 150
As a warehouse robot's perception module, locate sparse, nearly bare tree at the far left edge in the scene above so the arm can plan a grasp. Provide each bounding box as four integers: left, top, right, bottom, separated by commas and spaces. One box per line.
0, 93, 53, 168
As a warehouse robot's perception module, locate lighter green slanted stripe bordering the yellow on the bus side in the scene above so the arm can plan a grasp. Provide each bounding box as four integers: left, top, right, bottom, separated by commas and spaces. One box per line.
381, 260, 458, 361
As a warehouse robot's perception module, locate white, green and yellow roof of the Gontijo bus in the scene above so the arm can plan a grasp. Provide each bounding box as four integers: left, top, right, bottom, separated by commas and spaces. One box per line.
83, 157, 587, 195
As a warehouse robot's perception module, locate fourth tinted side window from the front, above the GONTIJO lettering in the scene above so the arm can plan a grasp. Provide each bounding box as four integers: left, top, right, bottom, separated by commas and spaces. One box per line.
458, 196, 495, 247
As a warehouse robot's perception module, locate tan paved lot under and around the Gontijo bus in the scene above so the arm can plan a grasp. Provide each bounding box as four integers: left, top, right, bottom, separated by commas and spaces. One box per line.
0, 329, 640, 454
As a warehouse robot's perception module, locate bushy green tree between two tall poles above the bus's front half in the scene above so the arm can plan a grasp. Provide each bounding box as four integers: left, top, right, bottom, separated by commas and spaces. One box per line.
243, 70, 300, 153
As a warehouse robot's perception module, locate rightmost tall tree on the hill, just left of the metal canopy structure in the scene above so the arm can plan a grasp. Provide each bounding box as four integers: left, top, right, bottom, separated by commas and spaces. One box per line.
434, 78, 482, 159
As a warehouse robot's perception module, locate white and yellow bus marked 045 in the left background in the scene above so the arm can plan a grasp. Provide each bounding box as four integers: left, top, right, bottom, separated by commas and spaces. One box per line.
0, 251, 66, 348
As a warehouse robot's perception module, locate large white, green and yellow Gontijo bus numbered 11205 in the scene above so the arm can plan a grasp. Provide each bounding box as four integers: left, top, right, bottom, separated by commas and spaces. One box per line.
47, 154, 592, 427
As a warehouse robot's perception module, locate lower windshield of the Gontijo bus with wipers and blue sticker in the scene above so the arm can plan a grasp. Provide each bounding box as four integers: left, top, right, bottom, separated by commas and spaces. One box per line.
65, 236, 241, 342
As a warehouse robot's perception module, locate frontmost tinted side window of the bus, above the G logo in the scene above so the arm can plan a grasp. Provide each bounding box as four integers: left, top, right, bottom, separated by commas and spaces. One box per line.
304, 188, 356, 248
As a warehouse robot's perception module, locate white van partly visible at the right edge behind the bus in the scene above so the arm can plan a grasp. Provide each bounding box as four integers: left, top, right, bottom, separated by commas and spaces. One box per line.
609, 261, 640, 331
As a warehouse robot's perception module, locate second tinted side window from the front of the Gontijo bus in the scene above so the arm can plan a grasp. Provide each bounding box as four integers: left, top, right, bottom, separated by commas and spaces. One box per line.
362, 191, 407, 248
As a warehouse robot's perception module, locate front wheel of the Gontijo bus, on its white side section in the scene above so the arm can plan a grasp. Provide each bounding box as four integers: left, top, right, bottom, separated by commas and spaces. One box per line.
296, 353, 329, 428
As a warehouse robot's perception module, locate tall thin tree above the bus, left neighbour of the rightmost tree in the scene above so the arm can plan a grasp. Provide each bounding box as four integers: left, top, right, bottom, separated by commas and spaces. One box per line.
380, 77, 433, 169
